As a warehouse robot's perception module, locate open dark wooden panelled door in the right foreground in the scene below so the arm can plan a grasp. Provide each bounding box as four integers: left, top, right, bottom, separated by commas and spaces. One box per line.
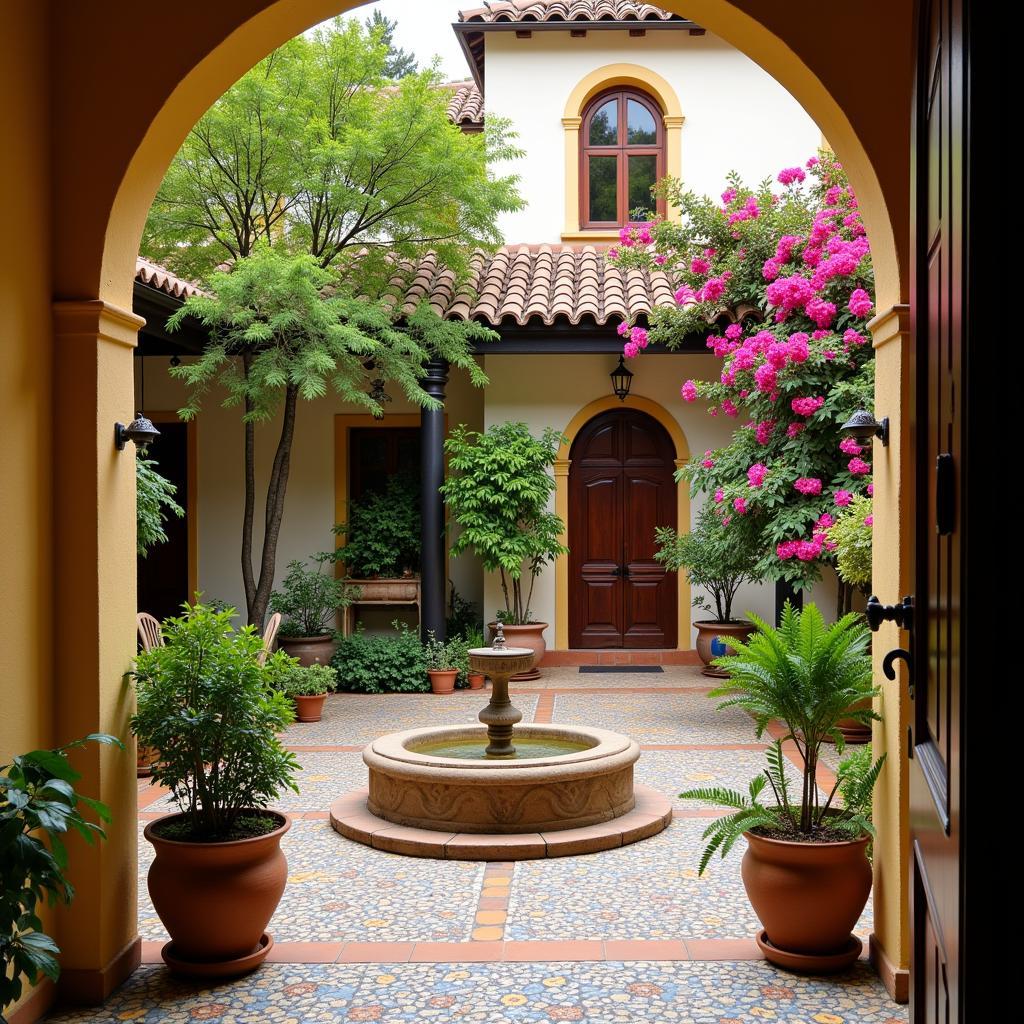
909, 0, 969, 1024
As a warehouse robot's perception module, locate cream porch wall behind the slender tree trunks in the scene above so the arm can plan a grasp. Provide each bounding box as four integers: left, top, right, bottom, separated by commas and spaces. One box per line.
136, 356, 483, 625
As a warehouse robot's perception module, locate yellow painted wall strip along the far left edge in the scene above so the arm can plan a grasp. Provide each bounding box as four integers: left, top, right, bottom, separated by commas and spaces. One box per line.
0, 8, 54, 1015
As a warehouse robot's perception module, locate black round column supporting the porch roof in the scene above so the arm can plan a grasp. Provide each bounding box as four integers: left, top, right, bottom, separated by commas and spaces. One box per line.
420, 359, 449, 640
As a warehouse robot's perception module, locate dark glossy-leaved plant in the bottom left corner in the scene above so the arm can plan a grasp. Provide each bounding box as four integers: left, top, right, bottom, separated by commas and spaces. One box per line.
0, 733, 122, 1021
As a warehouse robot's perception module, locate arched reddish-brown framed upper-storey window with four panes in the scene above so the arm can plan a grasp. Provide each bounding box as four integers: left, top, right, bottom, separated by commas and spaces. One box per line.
580, 89, 665, 228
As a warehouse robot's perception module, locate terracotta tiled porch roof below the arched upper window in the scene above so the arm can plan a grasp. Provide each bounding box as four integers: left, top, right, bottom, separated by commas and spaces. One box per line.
380, 246, 674, 327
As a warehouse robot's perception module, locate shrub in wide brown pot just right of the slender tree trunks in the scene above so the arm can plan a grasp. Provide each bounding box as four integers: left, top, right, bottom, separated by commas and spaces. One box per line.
270, 554, 359, 666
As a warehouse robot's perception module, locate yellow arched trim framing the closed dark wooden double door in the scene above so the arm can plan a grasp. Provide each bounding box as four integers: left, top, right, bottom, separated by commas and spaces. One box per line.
554, 394, 690, 650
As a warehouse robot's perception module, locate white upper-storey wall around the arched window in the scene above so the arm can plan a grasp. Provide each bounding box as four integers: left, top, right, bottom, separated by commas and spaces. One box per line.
485, 31, 821, 243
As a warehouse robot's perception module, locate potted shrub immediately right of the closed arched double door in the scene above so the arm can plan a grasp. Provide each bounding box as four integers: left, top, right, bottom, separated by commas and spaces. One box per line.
654, 505, 760, 678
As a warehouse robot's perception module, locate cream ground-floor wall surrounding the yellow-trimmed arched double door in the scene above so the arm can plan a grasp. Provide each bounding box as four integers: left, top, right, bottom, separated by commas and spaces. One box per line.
475, 355, 836, 647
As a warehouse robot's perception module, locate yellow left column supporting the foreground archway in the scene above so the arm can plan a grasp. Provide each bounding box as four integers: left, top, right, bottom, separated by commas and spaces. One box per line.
51, 299, 145, 1004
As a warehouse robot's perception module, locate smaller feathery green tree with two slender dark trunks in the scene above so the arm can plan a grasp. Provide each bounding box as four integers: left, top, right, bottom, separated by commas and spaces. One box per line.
168, 246, 495, 626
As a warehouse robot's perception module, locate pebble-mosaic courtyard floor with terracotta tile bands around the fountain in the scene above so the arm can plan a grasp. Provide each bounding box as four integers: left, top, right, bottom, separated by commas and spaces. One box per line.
58, 667, 906, 1024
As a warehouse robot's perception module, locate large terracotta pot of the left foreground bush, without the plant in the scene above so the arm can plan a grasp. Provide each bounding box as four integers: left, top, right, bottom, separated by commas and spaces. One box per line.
144, 811, 292, 976
